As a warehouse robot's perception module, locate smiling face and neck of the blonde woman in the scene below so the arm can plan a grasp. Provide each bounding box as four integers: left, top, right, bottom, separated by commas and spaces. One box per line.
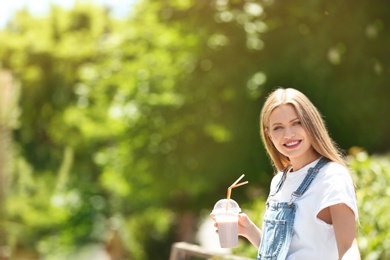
267, 105, 318, 170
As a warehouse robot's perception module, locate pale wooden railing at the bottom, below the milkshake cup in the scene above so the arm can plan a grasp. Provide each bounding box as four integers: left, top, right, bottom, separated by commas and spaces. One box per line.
169, 242, 253, 260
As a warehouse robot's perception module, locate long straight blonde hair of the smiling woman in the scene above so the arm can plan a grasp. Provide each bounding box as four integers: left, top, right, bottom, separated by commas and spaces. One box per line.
260, 88, 347, 171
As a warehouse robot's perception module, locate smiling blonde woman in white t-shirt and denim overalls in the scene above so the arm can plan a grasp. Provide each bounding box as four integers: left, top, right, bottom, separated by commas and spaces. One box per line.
216, 88, 360, 260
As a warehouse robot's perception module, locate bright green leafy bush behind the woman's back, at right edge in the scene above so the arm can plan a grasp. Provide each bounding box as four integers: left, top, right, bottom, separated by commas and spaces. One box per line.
350, 151, 390, 260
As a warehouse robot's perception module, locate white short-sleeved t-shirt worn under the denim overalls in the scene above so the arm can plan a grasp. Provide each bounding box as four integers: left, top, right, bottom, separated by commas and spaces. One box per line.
270, 160, 358, 260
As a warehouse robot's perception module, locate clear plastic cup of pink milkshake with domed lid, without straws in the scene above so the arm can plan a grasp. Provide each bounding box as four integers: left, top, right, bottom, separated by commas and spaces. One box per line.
212, 199, 241, 248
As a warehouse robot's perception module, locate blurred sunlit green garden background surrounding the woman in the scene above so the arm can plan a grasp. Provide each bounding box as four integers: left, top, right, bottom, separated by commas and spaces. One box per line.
0, 0, 390, 260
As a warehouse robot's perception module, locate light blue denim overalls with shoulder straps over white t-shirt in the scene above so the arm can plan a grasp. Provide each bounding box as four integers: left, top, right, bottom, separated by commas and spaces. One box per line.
256, 157, 329, 260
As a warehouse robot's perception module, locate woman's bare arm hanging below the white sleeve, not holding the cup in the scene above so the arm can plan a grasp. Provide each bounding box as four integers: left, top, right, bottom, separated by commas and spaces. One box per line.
329, 204, 360, 260
